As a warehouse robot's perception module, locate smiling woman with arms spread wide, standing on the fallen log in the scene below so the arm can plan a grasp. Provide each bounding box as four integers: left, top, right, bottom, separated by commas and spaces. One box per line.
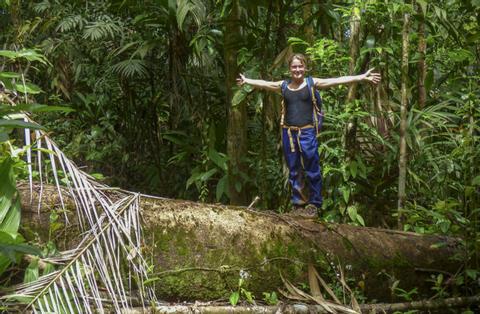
237, 54, 381, 217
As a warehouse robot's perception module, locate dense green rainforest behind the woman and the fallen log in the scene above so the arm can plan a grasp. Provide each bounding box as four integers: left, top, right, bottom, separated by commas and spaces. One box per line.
0, 0, 480, 310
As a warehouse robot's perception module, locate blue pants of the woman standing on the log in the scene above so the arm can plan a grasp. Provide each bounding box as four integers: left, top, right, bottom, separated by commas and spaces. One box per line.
282, 127, 322, 207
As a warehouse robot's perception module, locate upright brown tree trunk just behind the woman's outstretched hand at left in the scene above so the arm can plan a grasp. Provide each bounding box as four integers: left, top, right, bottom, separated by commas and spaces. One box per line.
224, 0, 247, 205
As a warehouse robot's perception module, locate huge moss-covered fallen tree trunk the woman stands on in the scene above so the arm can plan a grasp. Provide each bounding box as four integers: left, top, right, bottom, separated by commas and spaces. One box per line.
20, 186, 459, 302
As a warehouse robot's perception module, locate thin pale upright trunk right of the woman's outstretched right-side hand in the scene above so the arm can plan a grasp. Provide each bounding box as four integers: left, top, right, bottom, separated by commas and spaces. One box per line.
398, 12, 410, 230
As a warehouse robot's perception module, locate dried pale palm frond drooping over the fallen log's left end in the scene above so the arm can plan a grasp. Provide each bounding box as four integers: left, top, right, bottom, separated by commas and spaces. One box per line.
2, 115, 156, 313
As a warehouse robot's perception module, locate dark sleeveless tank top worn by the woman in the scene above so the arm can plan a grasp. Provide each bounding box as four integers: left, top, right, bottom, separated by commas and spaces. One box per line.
284, 85, 313, 127
